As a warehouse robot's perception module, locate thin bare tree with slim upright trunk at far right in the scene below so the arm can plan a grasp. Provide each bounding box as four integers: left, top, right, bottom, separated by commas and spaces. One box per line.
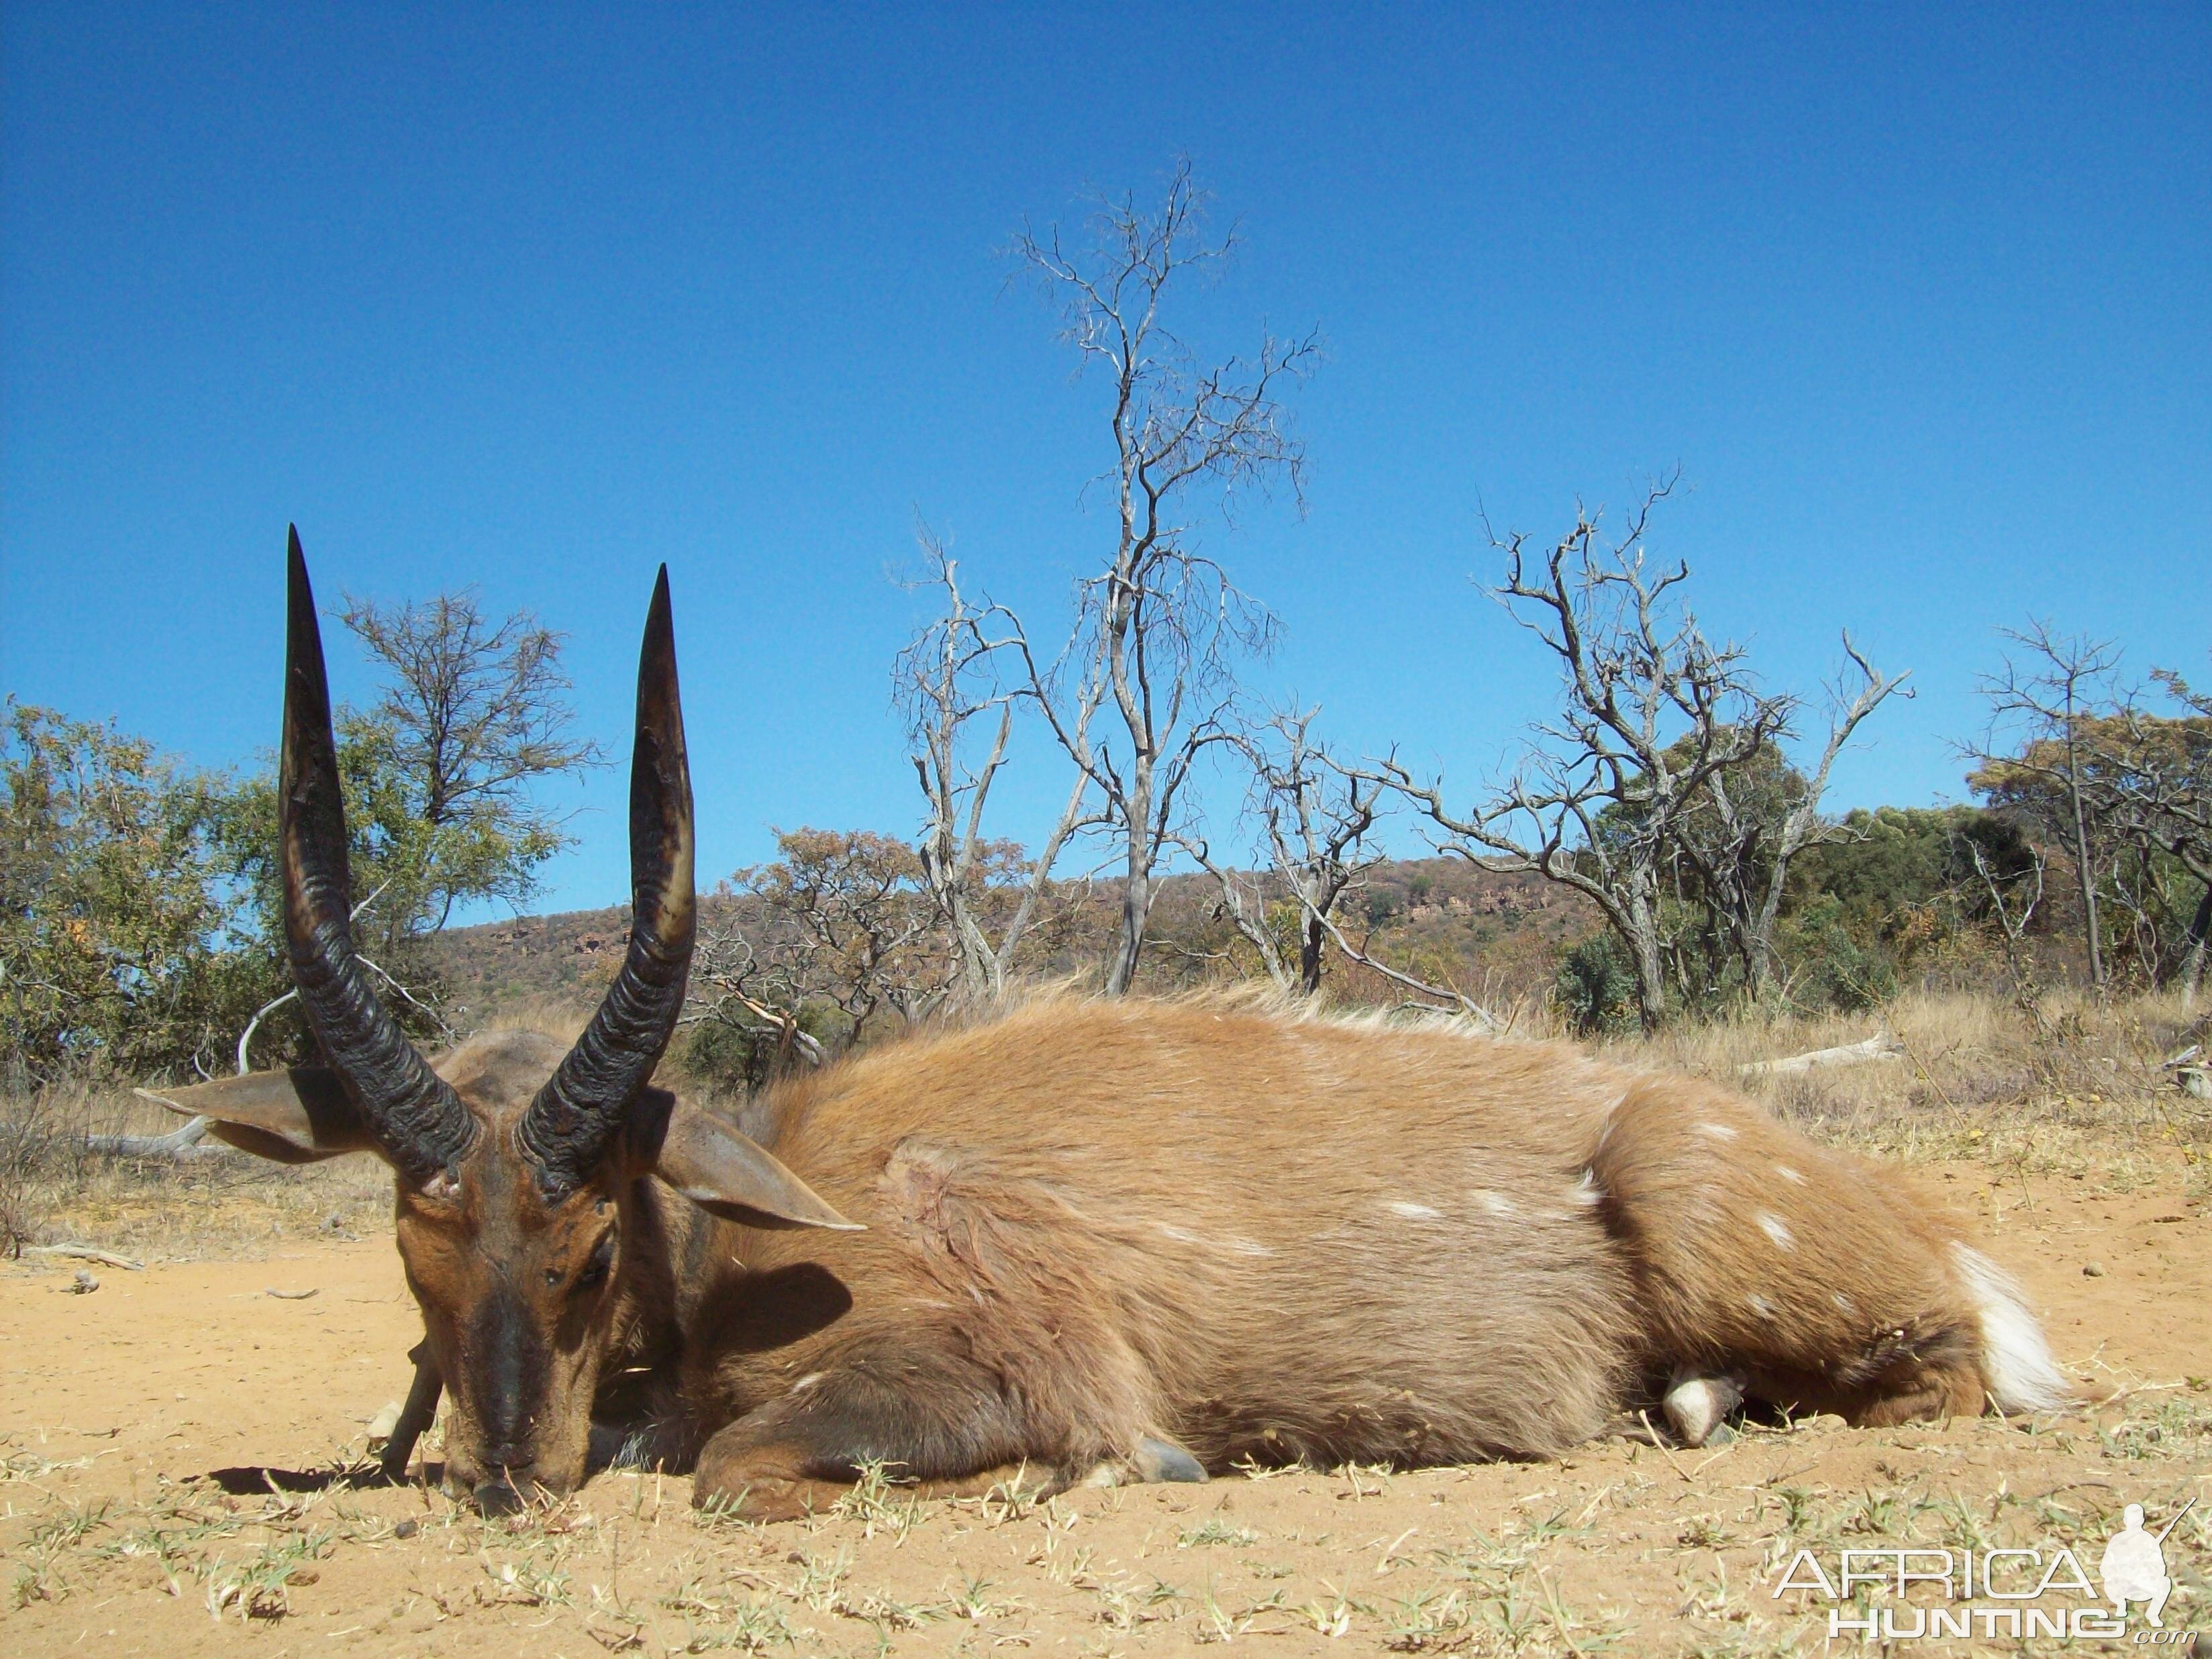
1966, 621, 2119, 989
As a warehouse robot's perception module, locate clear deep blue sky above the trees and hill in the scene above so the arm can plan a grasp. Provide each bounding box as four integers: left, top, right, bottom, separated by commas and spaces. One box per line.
0, 0, 2212, 907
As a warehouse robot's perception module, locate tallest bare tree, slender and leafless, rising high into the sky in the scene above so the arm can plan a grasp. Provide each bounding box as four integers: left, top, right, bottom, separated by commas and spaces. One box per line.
1011, 162, 1321, 995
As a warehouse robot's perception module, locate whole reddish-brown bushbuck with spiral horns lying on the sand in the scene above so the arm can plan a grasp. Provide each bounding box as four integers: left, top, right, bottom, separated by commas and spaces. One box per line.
151, 538, 2066, 1517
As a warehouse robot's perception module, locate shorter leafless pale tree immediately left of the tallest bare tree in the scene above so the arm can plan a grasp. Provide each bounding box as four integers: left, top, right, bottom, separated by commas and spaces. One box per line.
891, 526, 1106, 1002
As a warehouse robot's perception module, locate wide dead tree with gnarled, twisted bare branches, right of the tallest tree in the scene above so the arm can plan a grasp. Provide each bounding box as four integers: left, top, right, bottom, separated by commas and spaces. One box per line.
1362, 478, 1903, 1029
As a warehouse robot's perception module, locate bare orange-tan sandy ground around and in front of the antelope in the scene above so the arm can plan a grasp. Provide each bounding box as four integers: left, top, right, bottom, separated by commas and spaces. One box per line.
0, 1164, 2212, 1659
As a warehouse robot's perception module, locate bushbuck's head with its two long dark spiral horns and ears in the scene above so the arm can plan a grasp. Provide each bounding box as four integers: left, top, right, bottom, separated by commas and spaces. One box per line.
157, 529, 852, 1509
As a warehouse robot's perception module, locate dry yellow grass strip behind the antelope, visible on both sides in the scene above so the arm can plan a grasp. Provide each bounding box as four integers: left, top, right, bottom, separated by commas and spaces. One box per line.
0, 993, 2212, 1261
